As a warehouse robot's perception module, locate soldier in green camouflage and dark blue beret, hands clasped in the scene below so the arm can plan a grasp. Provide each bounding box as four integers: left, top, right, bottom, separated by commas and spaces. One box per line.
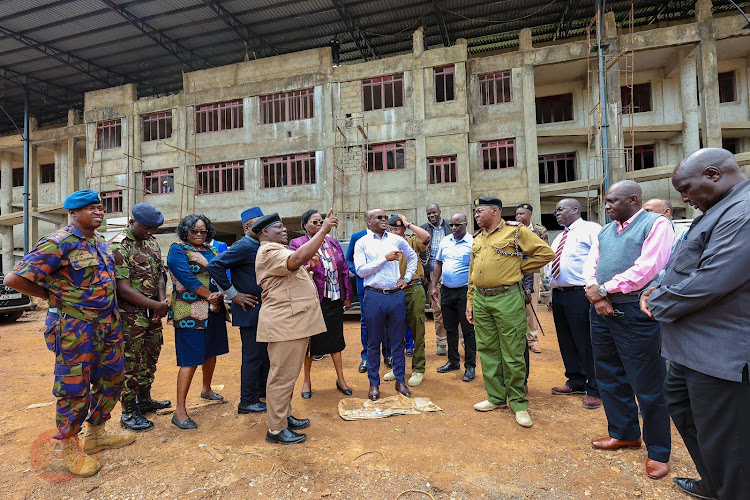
109, 203, 171, 431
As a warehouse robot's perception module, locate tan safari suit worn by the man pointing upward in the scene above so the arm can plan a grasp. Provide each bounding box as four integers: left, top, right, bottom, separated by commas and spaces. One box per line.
255, 241, 326, 431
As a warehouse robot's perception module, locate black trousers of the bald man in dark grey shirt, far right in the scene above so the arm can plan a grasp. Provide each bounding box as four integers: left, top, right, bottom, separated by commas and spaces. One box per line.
664, 362, 750, 500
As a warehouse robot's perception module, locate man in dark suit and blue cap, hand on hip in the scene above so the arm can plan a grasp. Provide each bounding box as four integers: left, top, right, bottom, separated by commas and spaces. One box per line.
208, 207, 270, 414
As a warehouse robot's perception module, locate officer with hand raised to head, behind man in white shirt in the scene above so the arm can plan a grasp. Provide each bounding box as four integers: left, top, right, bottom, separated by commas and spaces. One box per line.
383, 214, 430, 387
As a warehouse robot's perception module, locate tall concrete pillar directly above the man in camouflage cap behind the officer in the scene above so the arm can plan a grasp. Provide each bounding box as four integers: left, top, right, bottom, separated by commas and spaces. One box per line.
519, 28, 542, 224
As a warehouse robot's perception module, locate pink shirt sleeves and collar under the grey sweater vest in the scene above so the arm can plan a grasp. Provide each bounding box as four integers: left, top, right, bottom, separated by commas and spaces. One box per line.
583, 209, 674, 293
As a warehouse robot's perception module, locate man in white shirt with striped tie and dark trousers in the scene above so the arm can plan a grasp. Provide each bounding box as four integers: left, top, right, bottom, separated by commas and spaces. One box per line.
548, 198, 602, 410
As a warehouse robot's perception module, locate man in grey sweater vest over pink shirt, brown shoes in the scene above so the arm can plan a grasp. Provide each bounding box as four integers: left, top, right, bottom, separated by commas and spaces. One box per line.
584, 180, 674, 479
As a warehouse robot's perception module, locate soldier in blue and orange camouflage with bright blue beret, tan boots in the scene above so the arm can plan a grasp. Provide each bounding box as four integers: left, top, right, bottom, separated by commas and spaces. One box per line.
4, 190, 135, 477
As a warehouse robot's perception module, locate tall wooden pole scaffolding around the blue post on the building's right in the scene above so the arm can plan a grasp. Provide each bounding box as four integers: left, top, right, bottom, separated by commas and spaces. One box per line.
586, 3, 635, 221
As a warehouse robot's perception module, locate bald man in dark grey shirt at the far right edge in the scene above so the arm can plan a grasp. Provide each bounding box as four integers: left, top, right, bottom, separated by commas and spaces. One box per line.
641, 148, 750, 500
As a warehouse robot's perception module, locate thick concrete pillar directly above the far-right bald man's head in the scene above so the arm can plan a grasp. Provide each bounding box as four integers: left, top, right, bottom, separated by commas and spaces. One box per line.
696, 0, 721, 148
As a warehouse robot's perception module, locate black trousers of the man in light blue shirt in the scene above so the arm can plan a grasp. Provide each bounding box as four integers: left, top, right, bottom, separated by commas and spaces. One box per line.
440, 285, 477, 368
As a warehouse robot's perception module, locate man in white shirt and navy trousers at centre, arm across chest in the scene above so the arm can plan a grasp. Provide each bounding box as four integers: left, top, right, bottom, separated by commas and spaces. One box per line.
354, 208, 418, 401
